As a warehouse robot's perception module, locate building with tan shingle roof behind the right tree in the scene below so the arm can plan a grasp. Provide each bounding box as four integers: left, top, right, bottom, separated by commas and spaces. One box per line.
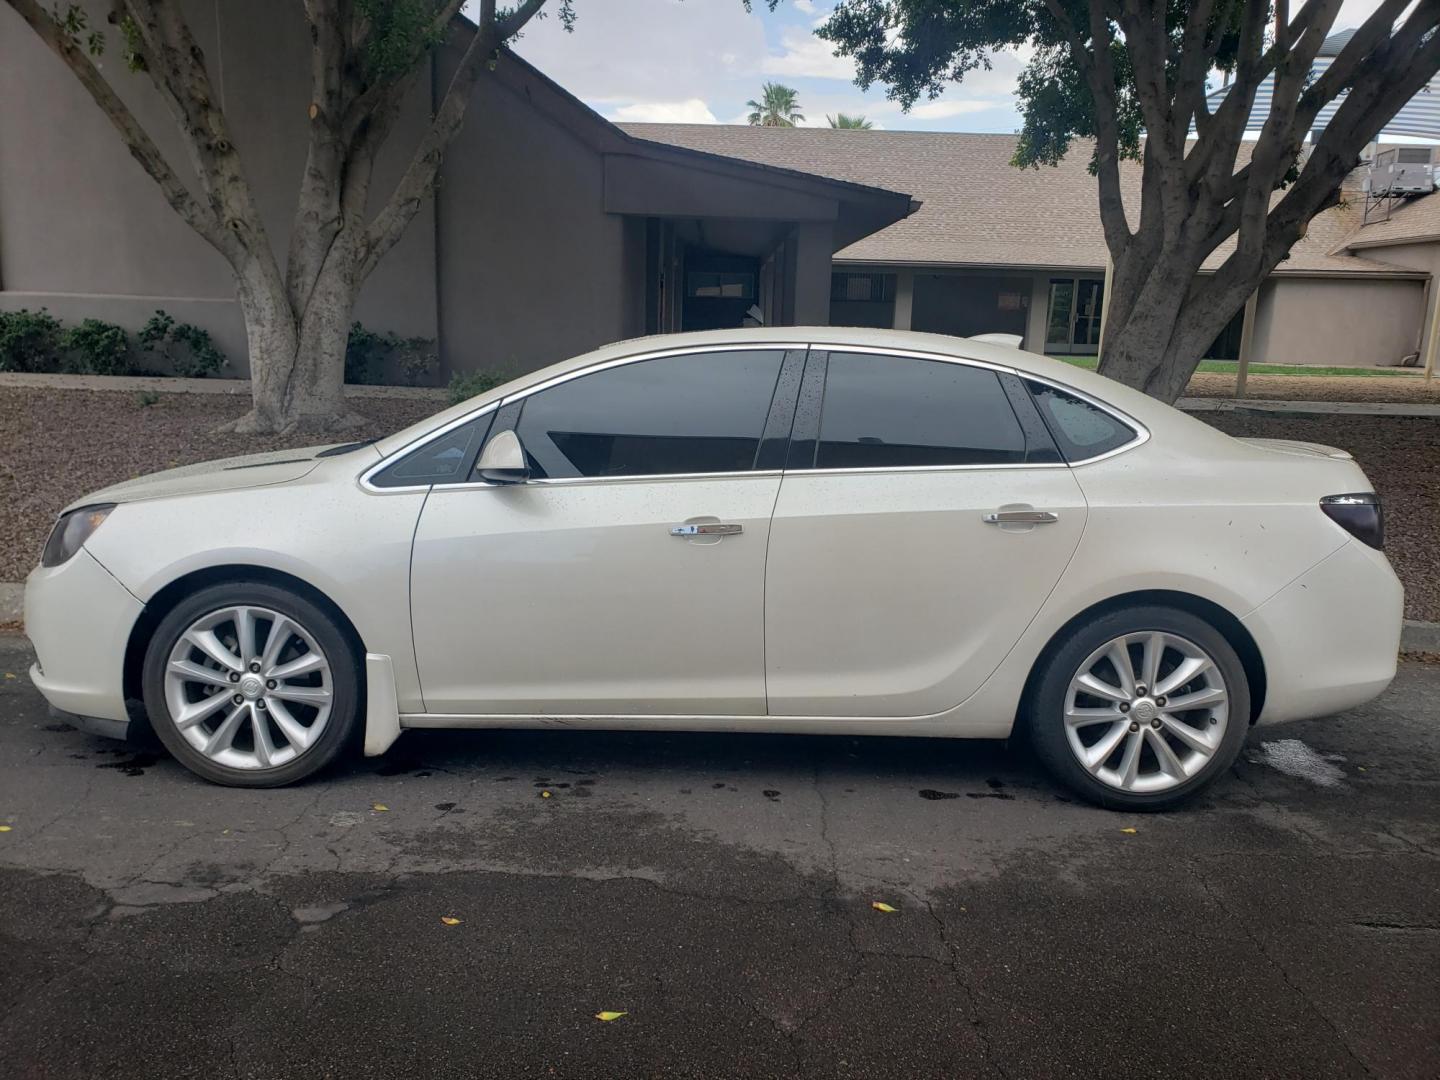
625, 124, 1440, 366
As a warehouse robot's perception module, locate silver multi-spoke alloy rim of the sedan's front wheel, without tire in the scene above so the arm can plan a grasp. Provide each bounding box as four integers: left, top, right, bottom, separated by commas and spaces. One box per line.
166, 606, 334, 769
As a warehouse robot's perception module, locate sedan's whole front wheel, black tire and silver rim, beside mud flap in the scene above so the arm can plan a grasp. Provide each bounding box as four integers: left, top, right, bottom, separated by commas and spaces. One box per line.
143, 580, 363, 788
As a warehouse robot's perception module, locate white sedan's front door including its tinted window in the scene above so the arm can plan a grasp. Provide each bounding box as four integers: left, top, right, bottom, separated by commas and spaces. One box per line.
410, 348, 804, 716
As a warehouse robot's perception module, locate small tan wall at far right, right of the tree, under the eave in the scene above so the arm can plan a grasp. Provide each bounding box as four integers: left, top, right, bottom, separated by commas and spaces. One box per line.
1250, 278, 1424, 367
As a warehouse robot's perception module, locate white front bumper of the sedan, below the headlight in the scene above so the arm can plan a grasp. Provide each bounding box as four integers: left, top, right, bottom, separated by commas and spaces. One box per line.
24, 549, 144, 723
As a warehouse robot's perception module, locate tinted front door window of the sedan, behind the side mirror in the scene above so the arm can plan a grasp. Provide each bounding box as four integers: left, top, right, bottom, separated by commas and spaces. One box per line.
516, 351, 785, 480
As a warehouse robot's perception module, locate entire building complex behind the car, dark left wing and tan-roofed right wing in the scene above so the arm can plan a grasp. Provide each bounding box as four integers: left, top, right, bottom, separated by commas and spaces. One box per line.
0, 0, 1440, 380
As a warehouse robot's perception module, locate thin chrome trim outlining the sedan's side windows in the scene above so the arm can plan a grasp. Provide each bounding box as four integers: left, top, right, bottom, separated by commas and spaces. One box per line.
357, 340, 1151, 495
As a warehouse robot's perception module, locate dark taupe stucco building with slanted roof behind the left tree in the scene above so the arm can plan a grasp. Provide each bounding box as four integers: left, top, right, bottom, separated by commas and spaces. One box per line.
0, 0, 912, 379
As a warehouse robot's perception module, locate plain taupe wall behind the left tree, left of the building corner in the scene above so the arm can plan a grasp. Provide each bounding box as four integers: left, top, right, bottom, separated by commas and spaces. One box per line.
0, 0, 436, 373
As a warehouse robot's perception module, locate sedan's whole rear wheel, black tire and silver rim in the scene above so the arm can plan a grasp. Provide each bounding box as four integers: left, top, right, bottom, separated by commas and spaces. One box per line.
1024, 606, 1250, 811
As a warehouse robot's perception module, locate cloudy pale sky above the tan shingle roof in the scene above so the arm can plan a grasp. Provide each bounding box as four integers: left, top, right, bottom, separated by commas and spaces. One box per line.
504, 0, 1380, 131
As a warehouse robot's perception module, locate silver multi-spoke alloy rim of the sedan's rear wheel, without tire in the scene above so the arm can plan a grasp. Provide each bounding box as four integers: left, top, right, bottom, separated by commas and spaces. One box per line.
1066, 631, 1230, 793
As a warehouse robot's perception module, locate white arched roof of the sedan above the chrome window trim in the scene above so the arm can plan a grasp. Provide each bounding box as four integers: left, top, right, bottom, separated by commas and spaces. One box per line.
376, 327, 1178, 456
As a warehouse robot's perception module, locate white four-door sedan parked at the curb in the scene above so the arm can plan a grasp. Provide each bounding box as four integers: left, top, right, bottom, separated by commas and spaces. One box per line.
26, 328, 1401, 809
